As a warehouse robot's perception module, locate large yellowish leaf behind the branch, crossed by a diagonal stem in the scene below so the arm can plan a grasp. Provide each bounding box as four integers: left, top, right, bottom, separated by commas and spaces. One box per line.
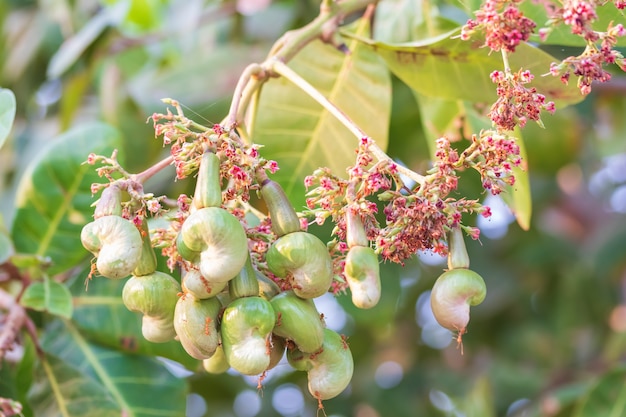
253, 19, 391, 207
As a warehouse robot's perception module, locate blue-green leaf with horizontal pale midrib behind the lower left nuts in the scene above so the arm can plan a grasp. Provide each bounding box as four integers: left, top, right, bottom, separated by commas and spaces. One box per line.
70, 271, 198, 368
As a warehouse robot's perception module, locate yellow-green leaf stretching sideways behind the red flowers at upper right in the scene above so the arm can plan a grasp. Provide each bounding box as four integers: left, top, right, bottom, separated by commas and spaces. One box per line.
348, 30, 584, 106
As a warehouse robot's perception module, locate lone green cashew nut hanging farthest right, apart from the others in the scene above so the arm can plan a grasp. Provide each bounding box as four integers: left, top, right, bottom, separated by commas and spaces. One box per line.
430, 269, 487, 336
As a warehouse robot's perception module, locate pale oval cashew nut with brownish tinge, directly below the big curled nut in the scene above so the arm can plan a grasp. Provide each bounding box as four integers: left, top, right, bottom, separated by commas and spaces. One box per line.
174, 294, 222, 360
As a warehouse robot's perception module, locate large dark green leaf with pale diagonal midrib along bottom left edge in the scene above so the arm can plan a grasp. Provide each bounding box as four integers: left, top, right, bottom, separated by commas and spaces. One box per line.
31, 321, 187, 417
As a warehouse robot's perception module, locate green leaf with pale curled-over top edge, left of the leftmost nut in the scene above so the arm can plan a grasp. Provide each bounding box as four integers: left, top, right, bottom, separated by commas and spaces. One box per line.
11, 122, 121, 274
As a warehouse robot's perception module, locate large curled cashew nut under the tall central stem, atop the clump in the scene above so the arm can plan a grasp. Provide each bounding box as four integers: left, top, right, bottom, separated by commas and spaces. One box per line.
179, 207, 248, 282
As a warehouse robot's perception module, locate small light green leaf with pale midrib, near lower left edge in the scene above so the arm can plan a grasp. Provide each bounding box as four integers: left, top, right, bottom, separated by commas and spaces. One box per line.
20, 277, 73, 319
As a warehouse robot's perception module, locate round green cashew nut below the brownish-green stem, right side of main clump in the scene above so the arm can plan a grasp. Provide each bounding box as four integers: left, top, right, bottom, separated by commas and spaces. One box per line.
265, 232, 333, 298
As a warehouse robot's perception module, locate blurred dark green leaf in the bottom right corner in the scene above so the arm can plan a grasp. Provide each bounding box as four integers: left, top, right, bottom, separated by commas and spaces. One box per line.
573, 366, 626, 417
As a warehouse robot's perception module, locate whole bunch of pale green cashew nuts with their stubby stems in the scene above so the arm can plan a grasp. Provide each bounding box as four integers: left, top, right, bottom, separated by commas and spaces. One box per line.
81, 151, 485, 401
